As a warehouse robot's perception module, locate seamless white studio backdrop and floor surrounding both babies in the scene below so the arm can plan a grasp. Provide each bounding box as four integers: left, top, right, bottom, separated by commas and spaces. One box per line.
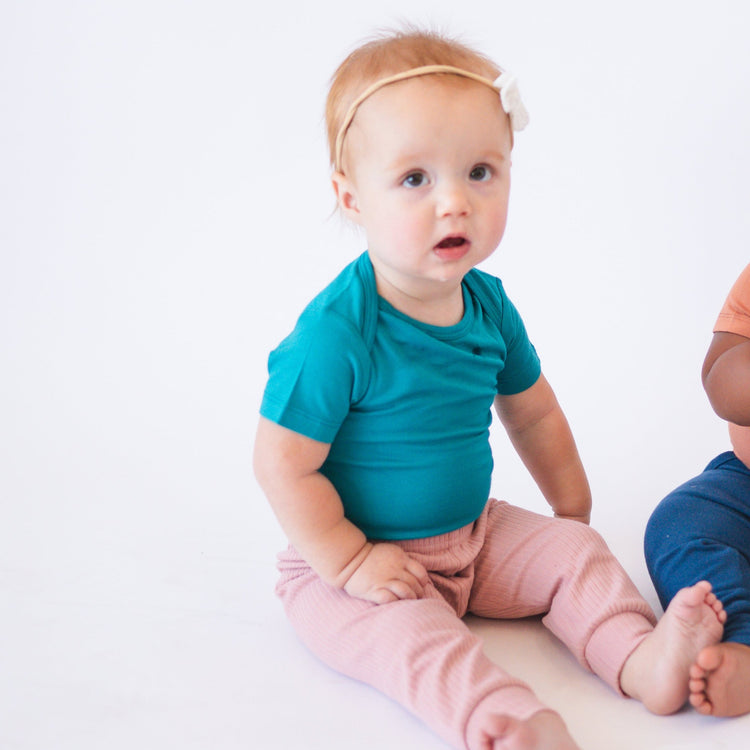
0, 0, 750, 750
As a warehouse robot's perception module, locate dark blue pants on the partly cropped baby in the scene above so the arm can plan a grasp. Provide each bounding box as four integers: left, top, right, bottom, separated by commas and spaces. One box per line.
645, 451, 750, 646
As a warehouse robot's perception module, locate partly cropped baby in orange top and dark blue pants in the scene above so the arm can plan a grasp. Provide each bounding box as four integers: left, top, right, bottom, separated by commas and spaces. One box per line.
645, 266, 750, 716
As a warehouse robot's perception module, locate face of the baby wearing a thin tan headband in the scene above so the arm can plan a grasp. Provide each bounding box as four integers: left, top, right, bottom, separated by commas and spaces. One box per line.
336, 75, 511, 293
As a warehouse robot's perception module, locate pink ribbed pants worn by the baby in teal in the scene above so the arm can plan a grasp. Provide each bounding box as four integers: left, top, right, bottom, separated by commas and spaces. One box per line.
277, 500, 656, 750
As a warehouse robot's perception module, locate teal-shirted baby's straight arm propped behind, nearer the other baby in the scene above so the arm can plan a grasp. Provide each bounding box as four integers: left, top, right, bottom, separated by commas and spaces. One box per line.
495, 375, 591, 523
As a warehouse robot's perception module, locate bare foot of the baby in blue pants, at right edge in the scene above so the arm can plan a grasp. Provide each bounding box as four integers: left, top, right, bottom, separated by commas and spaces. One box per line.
689, 642, 750, 716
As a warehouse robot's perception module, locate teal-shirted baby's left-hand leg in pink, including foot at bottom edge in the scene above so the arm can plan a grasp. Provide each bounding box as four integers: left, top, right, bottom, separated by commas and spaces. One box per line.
277, 553, 575, 750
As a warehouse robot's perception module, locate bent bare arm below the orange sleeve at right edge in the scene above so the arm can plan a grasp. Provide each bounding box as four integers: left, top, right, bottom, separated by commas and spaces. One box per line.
703, 332, 750, 425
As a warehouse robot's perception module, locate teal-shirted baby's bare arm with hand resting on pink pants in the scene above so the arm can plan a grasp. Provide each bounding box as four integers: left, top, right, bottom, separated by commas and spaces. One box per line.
253, 417, 427, 604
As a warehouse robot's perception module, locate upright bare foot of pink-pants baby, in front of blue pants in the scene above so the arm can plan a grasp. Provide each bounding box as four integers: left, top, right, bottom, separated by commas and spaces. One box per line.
620, 581, 727, 714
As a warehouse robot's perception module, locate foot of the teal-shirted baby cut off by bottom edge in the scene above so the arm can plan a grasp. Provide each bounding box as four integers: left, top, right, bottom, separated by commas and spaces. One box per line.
482, 711, 580, 750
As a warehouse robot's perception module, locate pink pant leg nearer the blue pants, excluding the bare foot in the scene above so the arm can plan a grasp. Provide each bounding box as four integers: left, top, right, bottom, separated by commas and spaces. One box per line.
470, 502, 656, 691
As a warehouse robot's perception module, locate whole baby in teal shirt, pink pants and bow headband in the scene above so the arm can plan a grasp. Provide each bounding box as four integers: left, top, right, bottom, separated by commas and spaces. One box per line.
254, 31, 724, 750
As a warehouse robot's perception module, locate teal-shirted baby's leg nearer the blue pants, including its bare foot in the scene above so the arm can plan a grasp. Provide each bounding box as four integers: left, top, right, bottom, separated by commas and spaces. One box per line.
471, 503, 723, 713
